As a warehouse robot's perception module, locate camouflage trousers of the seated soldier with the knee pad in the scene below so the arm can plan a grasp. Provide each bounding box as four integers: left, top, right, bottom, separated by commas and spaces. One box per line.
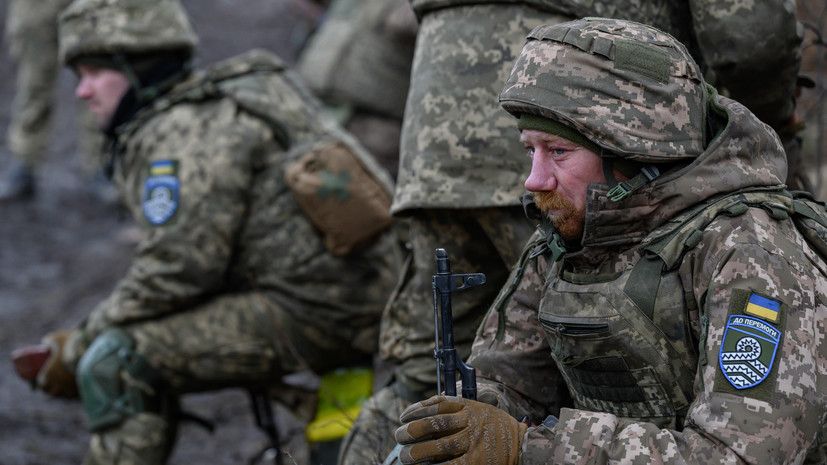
77, 293, 370, 465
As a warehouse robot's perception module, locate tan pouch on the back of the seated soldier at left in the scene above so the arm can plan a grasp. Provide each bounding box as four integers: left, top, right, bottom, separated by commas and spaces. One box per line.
285, 140, 393, 256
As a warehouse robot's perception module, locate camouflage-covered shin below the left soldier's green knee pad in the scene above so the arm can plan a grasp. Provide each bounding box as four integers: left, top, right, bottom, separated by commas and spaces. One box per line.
83, 413, 174, 465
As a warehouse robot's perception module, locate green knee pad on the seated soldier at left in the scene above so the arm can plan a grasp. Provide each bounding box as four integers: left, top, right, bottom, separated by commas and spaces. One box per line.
77, 328, 161, 431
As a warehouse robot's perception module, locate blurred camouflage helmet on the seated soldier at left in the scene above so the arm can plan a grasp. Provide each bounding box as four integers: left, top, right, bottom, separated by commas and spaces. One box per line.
59, 0, 198, 64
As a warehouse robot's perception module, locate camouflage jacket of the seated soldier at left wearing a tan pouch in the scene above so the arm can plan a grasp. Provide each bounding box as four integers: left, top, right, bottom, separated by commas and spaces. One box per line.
85, 51, 398, 350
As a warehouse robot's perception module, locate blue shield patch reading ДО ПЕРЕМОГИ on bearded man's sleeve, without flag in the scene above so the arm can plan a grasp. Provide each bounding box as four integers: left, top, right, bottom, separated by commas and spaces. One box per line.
718, 315, 781, 389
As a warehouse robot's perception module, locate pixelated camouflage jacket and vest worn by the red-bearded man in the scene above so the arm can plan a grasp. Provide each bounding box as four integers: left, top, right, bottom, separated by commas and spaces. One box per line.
468, 93, 827, 464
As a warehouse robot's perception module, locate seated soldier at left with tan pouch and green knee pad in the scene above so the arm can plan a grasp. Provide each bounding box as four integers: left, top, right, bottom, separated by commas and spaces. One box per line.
9, 0, 399, 464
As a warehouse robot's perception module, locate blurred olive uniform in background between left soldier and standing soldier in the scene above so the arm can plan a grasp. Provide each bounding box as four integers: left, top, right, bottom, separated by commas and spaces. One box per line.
297, 0, 417, 177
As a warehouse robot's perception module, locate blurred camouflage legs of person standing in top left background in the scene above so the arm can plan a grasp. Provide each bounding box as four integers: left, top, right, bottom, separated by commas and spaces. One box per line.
0, 0, 104, 201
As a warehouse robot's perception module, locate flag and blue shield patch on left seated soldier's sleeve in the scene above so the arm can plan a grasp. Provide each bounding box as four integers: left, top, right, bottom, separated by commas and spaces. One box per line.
143, 160, 180, 226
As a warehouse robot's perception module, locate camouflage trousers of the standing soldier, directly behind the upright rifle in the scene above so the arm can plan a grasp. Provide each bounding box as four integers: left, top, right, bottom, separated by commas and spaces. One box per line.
339, 207, 534, 465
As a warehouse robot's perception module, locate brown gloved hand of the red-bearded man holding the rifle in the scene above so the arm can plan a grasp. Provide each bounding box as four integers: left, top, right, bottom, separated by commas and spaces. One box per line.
394, 396, 528, 465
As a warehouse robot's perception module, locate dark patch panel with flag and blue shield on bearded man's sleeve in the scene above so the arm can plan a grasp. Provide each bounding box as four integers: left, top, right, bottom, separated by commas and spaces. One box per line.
715, 289, 784, 401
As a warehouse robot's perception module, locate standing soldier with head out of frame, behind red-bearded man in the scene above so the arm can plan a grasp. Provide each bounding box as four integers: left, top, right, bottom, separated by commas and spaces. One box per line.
344, 0, 800, 464
